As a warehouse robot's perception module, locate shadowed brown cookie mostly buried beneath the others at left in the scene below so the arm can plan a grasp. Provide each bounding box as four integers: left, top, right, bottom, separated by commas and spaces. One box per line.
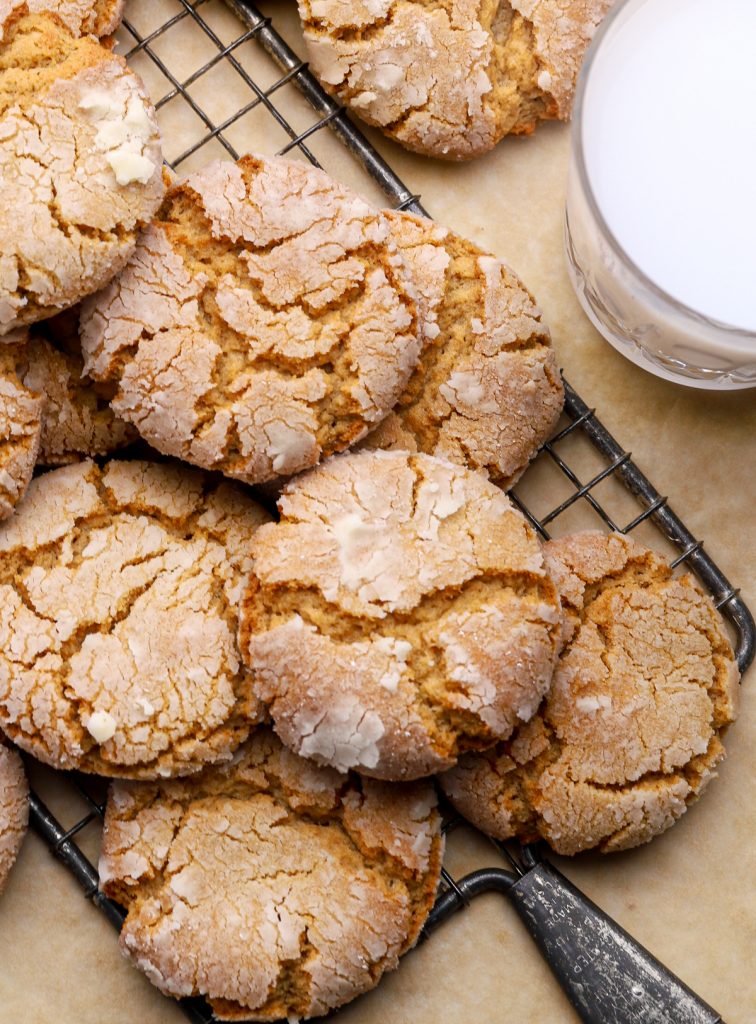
20, 306, 138, 466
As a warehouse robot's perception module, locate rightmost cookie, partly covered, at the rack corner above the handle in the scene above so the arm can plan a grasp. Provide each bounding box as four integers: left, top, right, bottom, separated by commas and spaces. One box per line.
442, 532, 740, 854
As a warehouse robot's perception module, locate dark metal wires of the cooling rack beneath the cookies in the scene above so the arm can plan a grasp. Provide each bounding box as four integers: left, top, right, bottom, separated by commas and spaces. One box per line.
26, 0, 756, 1024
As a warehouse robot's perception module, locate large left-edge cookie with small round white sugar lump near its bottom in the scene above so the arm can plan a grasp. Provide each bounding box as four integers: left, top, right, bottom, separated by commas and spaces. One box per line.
0, 461, 267, 778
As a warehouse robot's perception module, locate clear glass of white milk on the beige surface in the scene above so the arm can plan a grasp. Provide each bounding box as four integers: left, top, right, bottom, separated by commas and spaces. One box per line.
565, 0, 756, 390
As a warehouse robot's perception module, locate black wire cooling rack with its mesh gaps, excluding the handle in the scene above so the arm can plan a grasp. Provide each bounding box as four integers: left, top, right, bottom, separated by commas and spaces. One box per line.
26, 0, 756, 1024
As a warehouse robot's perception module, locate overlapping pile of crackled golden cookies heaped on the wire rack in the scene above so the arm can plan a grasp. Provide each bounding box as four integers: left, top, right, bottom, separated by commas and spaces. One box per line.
0, 2, 738, 1020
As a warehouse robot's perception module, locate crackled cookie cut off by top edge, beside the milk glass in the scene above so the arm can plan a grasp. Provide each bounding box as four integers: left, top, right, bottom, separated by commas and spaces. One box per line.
299, 0, 612, 160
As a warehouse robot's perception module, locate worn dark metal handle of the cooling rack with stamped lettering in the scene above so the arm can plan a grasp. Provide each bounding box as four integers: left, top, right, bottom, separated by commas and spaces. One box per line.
507, 861, 723, 1024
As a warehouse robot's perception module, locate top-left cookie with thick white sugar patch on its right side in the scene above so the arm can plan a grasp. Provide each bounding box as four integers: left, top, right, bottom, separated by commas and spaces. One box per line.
0, 7, 163, 334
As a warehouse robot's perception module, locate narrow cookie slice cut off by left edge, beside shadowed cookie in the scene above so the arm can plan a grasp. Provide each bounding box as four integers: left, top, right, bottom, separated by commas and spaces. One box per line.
0, 331, 43, 519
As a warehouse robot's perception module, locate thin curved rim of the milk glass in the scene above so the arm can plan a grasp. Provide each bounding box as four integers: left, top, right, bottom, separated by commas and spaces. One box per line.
571, 0, 756, 342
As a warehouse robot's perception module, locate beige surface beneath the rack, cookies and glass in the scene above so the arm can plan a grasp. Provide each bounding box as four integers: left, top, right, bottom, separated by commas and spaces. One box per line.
0, 0, 756, 1024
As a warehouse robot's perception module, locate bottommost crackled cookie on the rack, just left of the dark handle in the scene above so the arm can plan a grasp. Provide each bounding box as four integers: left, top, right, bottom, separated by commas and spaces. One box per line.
99, 730, 443, 1021
